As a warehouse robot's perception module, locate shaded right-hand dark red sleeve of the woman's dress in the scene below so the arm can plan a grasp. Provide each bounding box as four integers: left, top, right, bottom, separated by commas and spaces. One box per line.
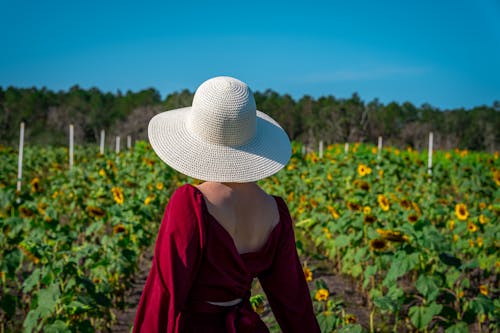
259, 198, 320, 333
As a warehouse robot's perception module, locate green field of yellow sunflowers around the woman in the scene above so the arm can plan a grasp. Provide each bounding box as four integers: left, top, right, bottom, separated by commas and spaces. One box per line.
0, 142, 500, 332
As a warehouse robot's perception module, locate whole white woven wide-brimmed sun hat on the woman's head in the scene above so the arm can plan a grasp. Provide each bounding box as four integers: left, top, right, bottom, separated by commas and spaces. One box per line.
148, 76, 291, 183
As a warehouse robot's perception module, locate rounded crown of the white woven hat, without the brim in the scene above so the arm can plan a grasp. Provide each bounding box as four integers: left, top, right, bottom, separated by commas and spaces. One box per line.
187, 76, 257, 147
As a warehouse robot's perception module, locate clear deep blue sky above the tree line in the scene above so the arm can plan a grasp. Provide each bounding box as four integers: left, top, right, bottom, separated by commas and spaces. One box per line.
0, 0, 500, 109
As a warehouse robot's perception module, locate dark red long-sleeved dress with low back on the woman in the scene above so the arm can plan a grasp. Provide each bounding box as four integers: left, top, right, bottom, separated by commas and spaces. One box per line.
133, 185, 320, 333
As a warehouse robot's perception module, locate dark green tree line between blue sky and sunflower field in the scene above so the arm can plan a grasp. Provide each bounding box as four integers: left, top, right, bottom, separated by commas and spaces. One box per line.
0, 86, 500, 152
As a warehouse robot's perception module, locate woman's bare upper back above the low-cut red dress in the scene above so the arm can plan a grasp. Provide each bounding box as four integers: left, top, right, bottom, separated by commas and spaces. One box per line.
197, 182, 279, 253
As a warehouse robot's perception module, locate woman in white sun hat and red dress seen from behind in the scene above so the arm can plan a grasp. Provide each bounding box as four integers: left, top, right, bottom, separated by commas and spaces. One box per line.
134, 77, 319, 333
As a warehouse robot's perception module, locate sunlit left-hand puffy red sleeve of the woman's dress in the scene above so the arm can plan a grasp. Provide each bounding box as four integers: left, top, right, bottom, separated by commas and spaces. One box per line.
133, 187, 204, 333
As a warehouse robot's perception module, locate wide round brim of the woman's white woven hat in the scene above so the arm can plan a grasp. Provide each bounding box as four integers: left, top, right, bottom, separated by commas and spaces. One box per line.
148, 107, 292, 183
